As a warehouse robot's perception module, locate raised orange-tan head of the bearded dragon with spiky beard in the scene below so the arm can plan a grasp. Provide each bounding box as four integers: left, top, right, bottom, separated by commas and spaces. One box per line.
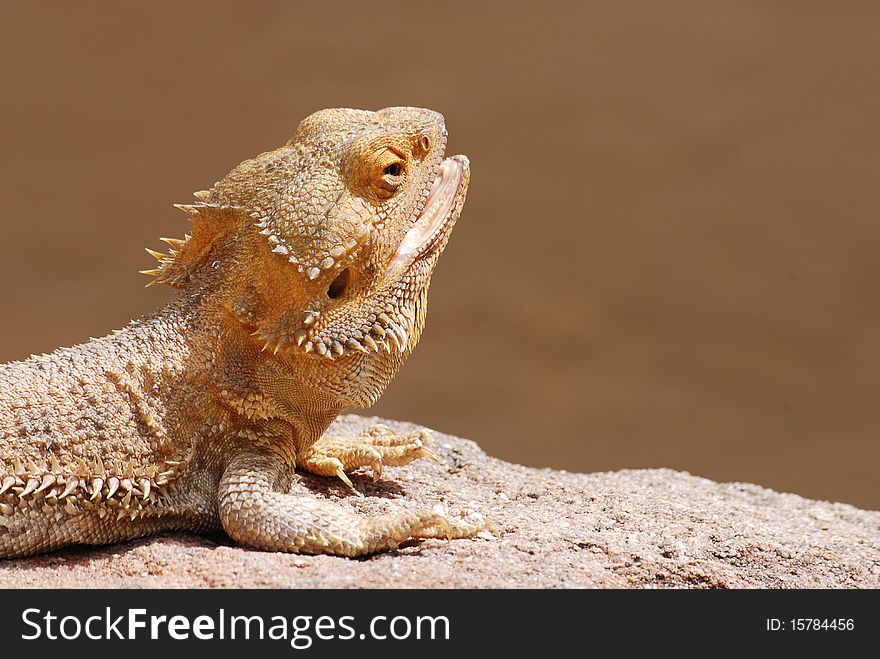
151, 107, 470, 406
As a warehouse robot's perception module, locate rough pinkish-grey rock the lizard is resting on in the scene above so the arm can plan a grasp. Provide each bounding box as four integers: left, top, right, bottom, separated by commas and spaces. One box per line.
0, 416, 880, 588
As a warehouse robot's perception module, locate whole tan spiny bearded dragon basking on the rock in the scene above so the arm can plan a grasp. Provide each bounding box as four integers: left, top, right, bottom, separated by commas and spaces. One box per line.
0, 108, 482, 557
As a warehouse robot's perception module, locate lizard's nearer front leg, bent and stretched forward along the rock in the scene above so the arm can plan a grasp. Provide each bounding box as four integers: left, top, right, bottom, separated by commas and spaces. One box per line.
218, 453, 485, 557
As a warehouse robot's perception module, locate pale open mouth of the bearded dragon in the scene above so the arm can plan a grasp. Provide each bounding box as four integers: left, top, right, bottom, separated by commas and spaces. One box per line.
388, 156, 469, 274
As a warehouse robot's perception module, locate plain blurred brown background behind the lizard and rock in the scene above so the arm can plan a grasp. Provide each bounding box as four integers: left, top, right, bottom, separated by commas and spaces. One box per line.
0, 0, 880, 509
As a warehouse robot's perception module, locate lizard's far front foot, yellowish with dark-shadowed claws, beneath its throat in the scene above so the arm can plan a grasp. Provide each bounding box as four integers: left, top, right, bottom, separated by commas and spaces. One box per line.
297, 424, 437, 492
